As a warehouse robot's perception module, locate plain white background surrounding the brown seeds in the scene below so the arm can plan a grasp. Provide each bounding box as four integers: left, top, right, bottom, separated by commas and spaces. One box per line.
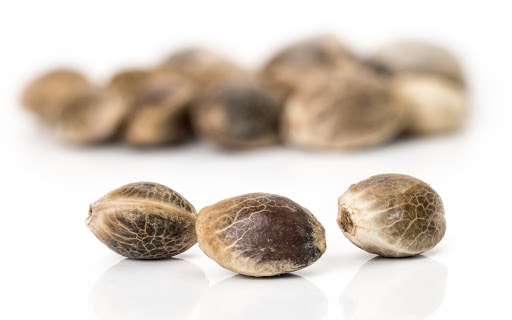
0, 0, 512, 319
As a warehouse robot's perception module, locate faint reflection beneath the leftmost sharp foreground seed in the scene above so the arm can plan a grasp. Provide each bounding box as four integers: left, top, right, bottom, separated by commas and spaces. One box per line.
90, 258, 208, 320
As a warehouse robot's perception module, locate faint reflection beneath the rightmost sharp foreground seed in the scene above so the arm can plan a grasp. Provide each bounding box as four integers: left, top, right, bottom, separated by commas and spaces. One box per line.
340, 256, 447, 320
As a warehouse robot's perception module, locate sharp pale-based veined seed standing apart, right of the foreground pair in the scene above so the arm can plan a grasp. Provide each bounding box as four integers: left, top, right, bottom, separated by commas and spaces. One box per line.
337, 174, 446, 257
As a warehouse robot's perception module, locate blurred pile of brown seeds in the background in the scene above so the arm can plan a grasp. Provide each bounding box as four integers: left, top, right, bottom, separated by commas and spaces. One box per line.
22, 35, 468, 149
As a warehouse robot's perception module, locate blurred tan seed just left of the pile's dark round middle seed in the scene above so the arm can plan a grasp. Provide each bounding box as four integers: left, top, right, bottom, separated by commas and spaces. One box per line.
123, 71, 194, 146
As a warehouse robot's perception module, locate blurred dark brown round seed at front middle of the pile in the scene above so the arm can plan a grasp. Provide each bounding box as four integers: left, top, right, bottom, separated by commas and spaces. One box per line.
192, 80, 281, 149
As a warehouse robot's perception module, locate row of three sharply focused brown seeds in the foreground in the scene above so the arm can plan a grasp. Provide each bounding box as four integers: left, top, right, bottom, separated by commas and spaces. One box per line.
86, 174, 446, 277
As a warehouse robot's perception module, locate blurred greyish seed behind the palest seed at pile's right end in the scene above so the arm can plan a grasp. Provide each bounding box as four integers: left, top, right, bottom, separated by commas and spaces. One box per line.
368, 40, 464, 84
